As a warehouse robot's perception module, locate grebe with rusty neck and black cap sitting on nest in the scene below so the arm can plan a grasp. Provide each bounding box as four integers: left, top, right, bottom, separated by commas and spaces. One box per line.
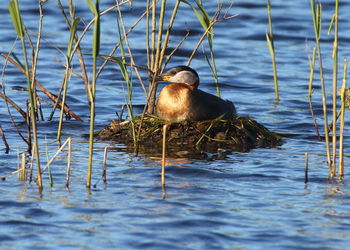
156, 66, 236, 122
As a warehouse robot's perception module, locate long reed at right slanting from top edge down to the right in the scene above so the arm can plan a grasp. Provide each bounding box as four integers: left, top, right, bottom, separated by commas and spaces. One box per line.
310, 0, 332, 170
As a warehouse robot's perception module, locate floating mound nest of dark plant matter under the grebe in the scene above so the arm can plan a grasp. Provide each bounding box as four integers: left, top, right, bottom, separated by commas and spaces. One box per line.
98, 115, 281, 156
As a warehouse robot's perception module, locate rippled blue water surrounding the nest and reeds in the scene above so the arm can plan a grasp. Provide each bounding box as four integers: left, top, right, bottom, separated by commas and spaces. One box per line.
0, 0, 350, 249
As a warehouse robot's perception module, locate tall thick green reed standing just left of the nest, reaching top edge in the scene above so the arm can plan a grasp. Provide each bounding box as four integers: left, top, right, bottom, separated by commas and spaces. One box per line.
86, 0, 100, 188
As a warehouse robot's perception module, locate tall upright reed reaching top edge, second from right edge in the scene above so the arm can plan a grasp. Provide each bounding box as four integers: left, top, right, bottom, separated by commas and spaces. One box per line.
331, 0, 339, 176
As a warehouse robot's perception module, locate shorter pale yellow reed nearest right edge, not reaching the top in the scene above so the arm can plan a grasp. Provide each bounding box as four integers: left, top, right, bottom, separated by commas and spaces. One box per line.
338, 59, 348, 178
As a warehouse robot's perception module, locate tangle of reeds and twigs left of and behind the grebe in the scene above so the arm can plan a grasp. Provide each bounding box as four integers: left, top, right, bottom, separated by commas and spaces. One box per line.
2, 0, 238, 190
